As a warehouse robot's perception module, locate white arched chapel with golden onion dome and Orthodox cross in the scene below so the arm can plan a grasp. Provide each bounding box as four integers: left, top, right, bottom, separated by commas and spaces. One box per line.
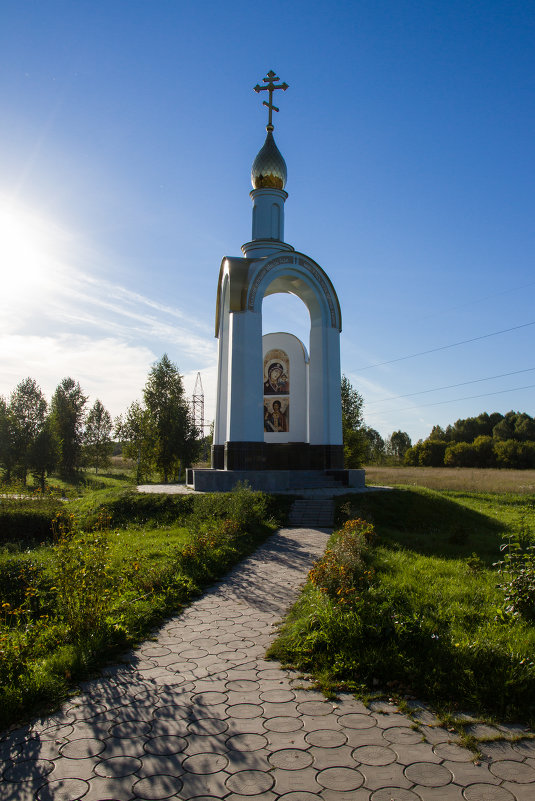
191, 72, 363, 491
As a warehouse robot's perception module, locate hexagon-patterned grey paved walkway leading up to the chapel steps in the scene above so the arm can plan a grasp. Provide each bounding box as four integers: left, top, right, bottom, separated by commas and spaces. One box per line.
0, 529, 535, 801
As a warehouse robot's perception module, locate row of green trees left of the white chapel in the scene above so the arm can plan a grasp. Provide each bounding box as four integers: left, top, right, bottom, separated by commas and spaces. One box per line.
0, 354, 201, 490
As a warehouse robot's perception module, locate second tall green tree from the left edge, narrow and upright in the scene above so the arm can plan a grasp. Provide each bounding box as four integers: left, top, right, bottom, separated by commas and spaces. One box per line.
51, 378, 87, 477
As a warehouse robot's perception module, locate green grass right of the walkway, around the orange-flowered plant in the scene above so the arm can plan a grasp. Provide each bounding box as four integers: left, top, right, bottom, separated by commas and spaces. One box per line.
270, 488, 535, 724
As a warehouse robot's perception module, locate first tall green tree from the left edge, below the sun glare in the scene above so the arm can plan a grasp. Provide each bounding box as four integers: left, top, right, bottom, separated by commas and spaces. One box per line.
9, 378, 47, 484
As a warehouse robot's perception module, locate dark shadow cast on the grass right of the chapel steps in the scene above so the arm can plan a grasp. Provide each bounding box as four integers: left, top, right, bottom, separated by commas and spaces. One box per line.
336, 489, 507, 566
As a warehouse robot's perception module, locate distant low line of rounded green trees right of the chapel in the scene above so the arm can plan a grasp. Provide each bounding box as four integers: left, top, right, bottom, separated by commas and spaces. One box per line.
404, 411, 535, 470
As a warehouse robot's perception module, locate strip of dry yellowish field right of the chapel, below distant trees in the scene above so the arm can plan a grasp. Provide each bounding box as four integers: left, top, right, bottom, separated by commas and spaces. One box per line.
366, 465, 535, 494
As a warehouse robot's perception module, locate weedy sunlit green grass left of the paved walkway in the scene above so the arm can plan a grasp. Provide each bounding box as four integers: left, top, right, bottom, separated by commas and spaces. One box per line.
0, 482, 286, 726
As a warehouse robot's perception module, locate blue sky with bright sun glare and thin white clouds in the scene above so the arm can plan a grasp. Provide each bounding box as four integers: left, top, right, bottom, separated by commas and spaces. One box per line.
0, 0, 535, 442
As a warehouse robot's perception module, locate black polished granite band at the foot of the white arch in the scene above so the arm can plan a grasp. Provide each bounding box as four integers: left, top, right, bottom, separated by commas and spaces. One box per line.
212, 442, 344, 470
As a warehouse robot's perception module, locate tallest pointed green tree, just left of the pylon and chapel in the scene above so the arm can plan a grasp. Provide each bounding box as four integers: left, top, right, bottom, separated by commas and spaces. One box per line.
143, 353, 198, 483
